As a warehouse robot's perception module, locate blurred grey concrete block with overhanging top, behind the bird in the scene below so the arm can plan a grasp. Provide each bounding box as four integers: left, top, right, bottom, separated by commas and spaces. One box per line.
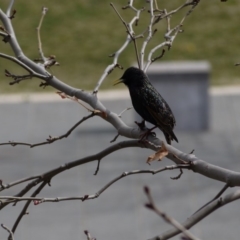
147, 61, 211, 131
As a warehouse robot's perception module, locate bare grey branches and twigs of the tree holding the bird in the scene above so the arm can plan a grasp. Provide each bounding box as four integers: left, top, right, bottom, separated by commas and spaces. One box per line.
0, 0, 240, 239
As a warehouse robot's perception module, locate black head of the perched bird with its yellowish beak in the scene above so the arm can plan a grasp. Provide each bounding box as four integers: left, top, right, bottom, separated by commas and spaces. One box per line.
114, 67, 147, 87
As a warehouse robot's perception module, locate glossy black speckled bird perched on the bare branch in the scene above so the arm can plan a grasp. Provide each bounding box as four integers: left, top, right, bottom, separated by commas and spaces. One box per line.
115, 67, 178, 144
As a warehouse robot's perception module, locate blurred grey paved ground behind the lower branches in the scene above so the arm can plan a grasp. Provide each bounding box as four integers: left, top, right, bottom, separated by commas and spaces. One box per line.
0, 94, 240, 240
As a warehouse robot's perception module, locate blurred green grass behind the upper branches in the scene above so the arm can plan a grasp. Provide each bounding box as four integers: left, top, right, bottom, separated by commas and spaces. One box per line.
0, 0, 240, 92
